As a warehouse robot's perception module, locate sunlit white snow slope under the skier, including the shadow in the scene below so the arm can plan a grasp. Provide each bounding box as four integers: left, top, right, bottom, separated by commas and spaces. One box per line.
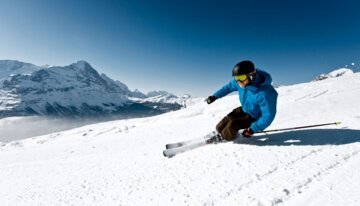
0, 70, 360, 206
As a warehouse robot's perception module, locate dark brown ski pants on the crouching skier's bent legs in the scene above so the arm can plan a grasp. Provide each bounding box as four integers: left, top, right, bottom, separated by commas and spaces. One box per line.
216, 107, 255, 141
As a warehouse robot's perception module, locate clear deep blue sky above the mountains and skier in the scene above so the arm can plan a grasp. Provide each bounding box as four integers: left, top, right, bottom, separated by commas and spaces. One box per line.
0, 0, 360, 96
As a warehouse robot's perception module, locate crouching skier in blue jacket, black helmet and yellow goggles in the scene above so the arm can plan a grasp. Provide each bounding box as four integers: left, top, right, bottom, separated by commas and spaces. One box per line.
206, 60, 278, 141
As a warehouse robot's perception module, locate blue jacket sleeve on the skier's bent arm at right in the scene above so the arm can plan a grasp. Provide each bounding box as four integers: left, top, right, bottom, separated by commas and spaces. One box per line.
250, 90, 277, 132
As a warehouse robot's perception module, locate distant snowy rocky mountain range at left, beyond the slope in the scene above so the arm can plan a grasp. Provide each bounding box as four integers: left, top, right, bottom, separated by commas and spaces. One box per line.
0, 60, 190, 118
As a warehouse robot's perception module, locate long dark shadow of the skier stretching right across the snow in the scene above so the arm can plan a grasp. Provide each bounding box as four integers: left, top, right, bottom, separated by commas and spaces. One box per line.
234, 129, 360, 146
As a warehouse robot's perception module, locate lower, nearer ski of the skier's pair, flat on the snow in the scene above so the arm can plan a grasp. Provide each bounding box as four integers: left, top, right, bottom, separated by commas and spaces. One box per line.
163, 134, 222, 158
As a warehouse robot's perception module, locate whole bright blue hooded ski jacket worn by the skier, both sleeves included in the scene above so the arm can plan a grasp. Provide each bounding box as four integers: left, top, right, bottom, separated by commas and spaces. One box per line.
213, 69, 278, 132
